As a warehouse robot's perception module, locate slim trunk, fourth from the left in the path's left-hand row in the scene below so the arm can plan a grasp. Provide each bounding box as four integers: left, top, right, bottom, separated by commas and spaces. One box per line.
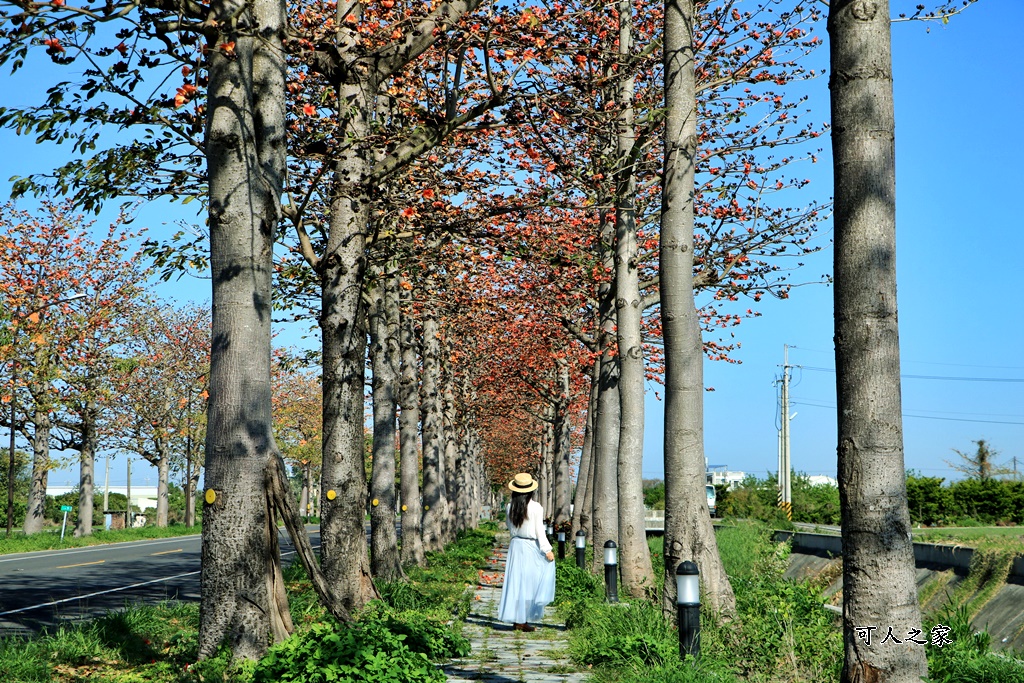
398, 272, 424, 565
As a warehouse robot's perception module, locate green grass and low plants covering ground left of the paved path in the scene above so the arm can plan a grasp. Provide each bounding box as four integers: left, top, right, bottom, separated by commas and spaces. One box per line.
0, 524, 494, 683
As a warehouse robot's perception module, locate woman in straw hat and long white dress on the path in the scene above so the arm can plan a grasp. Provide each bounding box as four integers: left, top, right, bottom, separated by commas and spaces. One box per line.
498, 473, 555, 632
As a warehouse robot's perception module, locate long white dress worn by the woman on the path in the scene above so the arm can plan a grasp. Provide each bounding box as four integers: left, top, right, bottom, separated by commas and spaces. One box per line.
498, 501, 555, 624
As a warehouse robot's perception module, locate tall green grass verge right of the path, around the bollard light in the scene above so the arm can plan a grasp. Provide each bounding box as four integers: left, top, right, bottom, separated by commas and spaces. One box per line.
556, 523, 1024, 683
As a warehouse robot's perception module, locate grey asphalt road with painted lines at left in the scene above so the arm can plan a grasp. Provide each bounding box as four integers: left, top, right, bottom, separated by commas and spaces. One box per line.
0, 527, 319, 637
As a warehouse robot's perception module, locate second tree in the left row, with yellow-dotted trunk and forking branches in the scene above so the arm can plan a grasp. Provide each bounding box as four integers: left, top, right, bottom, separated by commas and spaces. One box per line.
268, 0, 536, 607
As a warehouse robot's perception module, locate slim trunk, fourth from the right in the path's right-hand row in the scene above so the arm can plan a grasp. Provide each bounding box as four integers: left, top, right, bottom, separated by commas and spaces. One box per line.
591, 214, 618, 571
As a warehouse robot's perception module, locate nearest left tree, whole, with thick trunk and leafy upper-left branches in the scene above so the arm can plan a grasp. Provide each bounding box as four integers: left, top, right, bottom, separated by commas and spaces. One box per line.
0, 0, 347, 657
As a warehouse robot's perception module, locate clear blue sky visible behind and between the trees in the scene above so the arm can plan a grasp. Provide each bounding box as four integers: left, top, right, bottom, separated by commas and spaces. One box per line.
0, 0, 1024, 491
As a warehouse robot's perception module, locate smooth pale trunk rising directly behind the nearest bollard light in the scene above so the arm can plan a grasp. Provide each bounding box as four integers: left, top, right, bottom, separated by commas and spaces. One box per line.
660, 0, 736, 614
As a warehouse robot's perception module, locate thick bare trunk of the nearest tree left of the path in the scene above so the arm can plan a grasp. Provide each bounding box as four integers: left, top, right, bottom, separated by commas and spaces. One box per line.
199, 0, 286, 659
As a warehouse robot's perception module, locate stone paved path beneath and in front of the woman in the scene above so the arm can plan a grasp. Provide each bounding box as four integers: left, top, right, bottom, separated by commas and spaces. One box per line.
442, 536, 586, 683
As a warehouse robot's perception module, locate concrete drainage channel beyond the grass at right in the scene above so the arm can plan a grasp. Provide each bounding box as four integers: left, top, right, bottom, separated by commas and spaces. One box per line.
773, 531, 1024, 649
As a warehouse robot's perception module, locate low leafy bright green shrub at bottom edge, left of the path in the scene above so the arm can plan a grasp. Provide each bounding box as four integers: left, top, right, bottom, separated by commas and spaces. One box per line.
253, 620, 444, 683
